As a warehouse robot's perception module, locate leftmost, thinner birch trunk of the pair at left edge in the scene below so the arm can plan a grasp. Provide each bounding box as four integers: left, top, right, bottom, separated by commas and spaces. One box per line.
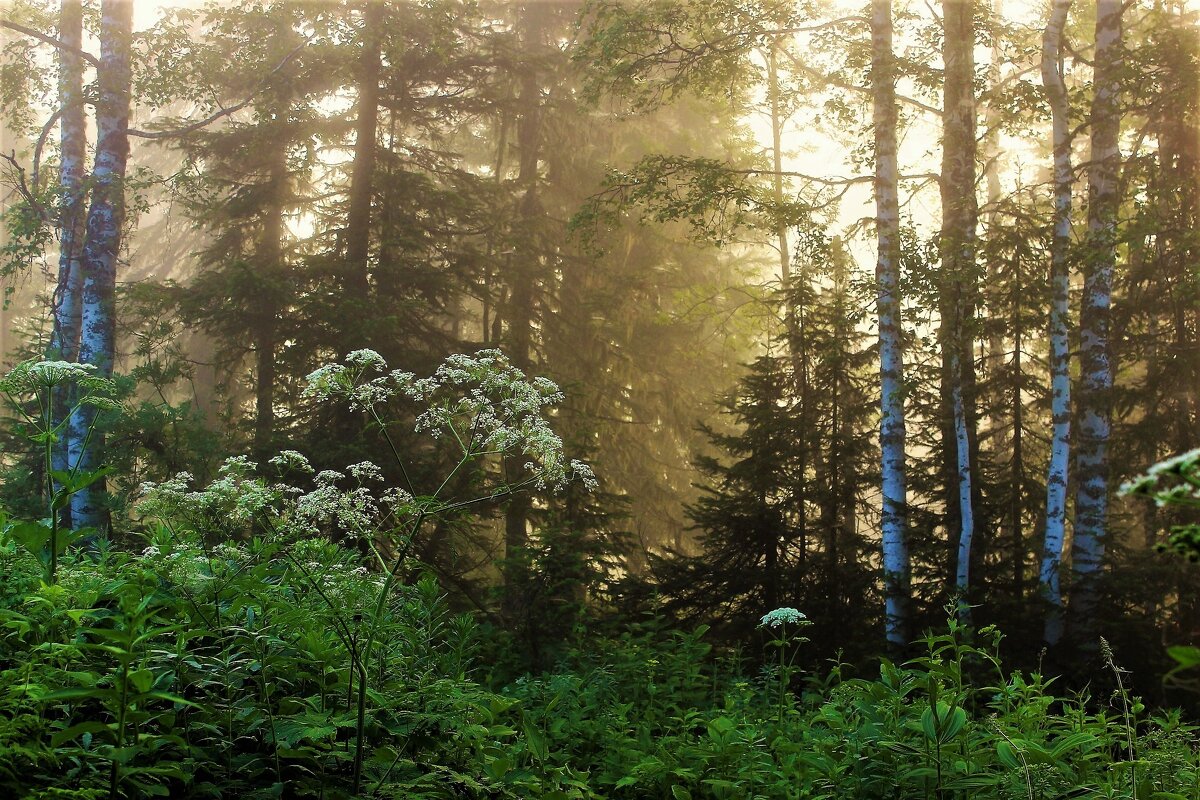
49, 0, 88, 528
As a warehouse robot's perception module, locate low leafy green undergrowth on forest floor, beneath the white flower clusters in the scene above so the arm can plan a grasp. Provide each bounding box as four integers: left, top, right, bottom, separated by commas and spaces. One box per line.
0, 527, 1200, 800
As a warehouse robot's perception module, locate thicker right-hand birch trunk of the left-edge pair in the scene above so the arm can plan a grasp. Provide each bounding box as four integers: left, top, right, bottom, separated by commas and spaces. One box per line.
70, 0, 133, 537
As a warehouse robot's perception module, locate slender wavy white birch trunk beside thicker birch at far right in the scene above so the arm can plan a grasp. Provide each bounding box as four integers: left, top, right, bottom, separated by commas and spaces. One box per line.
1038, 0, 1074, 645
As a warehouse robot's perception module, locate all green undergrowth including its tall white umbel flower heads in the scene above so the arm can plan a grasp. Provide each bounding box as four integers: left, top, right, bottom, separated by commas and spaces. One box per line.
0, 351, 1200, 800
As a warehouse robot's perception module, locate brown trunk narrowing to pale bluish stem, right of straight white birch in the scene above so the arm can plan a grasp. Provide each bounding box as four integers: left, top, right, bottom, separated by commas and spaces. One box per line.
941, 0, 979, 622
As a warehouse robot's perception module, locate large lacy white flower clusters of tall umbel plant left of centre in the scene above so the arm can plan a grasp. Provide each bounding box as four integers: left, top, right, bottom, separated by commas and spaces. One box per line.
140, 350, 596, 551
